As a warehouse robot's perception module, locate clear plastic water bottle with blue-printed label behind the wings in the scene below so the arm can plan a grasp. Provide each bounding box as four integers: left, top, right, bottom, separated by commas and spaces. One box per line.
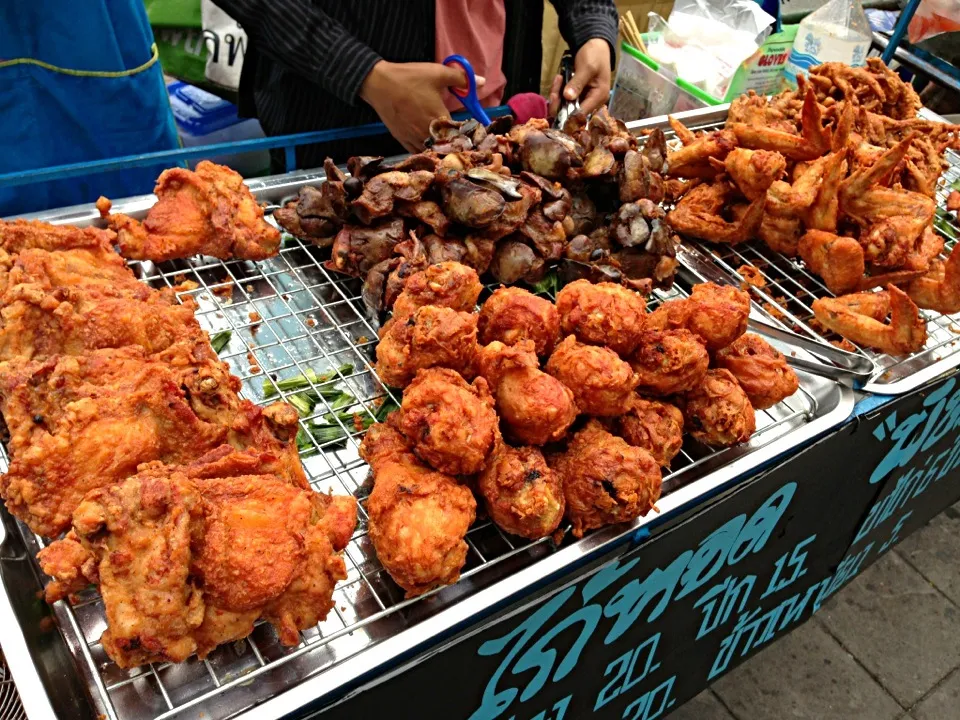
783, 0, 872, 88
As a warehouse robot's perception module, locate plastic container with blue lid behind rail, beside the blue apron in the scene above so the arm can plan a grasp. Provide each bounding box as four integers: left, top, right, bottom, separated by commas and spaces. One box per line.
167, 81, 270, 177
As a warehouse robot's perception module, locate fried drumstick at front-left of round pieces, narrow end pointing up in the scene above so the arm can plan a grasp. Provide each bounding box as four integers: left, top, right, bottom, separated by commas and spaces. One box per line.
360, 424, 477, 597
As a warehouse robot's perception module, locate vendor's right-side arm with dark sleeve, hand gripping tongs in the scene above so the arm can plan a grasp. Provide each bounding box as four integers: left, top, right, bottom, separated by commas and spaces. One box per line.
550, 0, 619, 115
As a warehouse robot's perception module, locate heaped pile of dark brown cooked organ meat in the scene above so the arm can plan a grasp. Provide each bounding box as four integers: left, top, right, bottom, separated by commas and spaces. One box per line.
274, 108, 679, 312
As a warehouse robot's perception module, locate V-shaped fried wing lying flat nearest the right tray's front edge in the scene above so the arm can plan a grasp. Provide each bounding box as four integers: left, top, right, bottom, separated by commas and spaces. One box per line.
812, 285, 927, 355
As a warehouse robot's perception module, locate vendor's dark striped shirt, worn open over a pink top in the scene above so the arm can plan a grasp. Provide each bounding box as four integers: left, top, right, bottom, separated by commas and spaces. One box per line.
214, 0, 618, 167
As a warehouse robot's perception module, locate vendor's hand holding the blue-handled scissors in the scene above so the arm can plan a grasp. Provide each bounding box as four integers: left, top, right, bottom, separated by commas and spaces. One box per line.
360, 60, 484, 153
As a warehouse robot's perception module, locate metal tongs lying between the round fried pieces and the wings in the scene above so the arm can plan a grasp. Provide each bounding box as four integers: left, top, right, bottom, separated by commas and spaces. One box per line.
677, 245, 876, 384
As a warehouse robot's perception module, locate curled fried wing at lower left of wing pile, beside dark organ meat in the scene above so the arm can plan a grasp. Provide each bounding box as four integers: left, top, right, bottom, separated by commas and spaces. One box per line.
667, 182, 766, 245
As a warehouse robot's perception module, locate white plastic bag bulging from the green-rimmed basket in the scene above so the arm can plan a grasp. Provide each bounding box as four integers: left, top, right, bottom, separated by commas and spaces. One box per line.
647, 0, 774, 98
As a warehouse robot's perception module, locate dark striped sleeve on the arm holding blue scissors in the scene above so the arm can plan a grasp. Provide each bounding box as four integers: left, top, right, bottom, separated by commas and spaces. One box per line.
214, 0, 381, 105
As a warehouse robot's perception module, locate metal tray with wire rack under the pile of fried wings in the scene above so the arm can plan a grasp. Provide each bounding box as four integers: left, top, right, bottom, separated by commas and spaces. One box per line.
627, 104, 960, 395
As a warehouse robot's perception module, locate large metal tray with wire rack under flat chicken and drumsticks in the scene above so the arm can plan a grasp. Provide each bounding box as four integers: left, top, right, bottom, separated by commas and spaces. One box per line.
0, 172, 853, 720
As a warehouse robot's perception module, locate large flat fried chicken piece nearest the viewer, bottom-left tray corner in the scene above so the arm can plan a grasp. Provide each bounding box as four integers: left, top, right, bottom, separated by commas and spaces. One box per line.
38, 447, 356, 668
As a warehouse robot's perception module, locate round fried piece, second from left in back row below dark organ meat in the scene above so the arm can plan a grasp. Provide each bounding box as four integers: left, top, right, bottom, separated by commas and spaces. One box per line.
477, 287, 560, 356
